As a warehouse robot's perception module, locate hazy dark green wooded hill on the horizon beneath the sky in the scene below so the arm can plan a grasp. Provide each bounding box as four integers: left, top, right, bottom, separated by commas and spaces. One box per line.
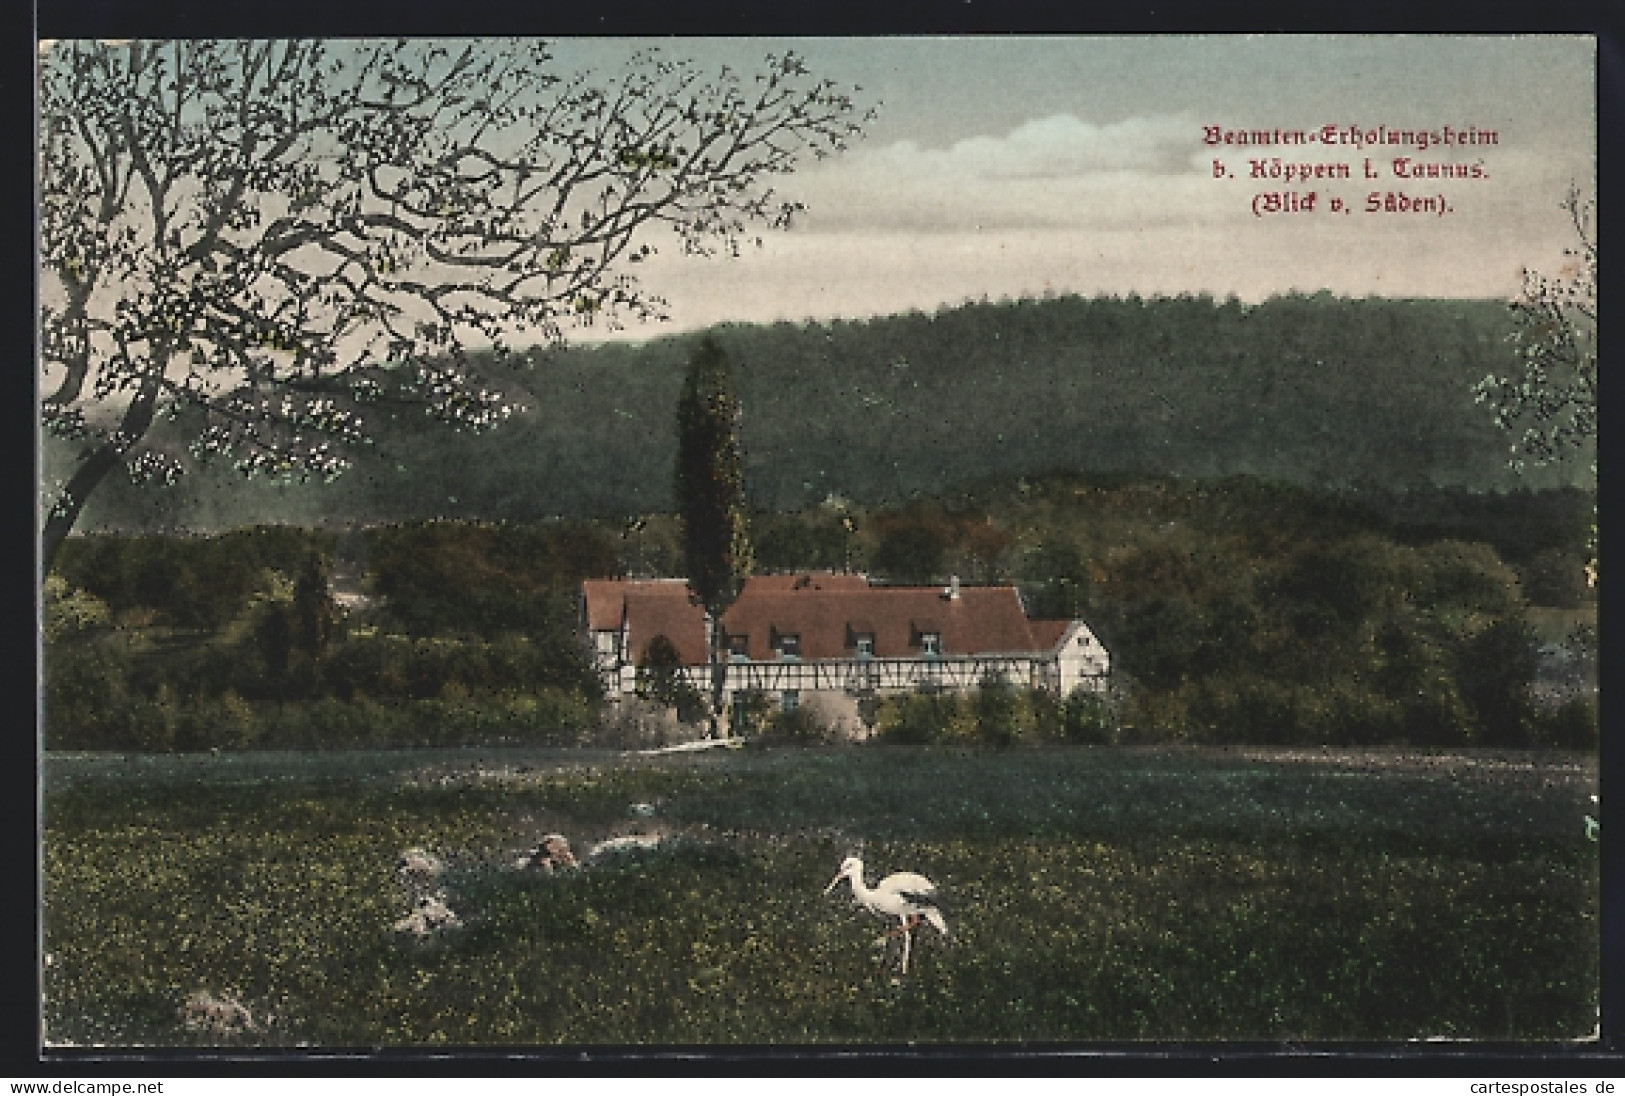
47, 294, 1586, 528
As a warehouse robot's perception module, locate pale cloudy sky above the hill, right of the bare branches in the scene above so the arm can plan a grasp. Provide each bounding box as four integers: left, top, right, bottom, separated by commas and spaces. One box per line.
536, 36, 1596, 338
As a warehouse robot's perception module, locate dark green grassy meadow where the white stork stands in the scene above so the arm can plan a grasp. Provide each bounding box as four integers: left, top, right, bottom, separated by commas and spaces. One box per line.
44, 748, 1597, 1046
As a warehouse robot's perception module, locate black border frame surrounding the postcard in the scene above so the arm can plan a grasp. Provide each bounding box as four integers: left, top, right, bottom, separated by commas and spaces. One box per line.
15, 0, 1625, 1080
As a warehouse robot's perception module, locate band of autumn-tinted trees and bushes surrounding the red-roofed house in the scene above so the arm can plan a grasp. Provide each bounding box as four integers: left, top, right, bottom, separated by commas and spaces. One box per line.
46, 473, 1596, 750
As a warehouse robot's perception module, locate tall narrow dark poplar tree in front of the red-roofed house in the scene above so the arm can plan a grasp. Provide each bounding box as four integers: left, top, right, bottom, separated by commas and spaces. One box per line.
676, 335, 752, 738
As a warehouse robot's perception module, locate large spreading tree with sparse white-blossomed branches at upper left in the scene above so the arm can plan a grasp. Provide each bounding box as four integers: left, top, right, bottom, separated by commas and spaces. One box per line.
39, 41, 873, 569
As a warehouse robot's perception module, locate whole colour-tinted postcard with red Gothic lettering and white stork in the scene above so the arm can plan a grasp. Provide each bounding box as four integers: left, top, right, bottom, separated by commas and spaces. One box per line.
37, 36, 1604, 1057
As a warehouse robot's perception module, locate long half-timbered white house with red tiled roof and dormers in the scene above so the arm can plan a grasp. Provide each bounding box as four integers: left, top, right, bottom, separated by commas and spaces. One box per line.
582, 572, 1112, 724
